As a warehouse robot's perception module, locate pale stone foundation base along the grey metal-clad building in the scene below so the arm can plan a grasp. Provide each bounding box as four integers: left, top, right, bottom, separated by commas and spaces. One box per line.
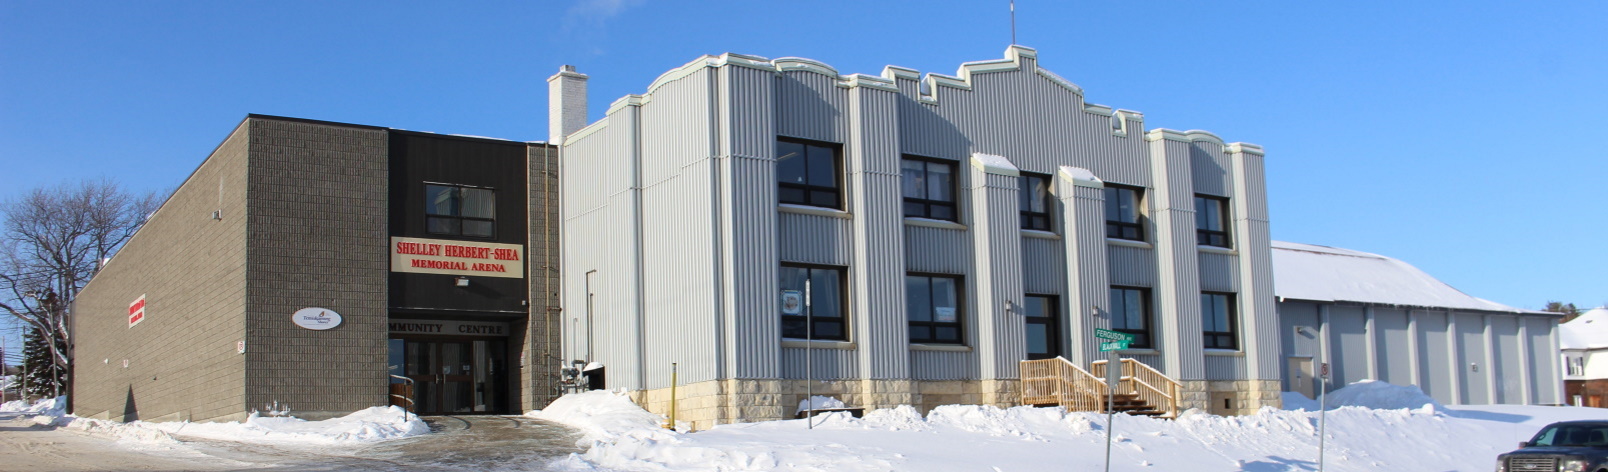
630, 379, 1280, 430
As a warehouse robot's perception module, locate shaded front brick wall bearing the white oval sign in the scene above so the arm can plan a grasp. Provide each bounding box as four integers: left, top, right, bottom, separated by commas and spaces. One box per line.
244, 117, 389, 419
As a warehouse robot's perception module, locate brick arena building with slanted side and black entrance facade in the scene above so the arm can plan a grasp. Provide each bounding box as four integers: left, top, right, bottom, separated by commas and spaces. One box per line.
71, 116, 558, 421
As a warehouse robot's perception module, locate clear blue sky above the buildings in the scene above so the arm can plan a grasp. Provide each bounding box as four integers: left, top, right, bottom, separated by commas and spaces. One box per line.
0, 0, 1608, 319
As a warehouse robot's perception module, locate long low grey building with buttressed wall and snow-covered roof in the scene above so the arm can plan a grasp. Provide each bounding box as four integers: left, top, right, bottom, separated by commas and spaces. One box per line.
1274, 241, 1556, 405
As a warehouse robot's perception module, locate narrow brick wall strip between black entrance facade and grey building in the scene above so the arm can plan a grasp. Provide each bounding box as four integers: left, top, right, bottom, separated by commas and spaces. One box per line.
511, 144, 561, 409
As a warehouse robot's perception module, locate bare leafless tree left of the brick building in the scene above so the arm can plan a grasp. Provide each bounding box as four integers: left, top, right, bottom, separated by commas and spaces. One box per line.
0, 180, 161, 395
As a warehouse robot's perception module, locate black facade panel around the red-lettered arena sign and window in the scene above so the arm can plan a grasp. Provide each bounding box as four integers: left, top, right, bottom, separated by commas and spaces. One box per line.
389, 130, 529, 316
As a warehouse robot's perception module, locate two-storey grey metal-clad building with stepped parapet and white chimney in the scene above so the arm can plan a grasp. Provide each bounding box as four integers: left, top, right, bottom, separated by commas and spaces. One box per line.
562, 47, 1280, 427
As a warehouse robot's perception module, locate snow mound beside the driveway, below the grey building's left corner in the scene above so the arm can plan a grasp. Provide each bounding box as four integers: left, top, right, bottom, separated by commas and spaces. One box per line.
524, 390, 664, 446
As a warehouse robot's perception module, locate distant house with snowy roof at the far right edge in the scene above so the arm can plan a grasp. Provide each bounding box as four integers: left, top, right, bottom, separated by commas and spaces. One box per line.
1558, 308, 1608, 408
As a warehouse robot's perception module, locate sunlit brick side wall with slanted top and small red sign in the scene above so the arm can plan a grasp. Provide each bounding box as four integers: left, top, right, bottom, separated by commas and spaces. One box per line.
72, 120, 252, 421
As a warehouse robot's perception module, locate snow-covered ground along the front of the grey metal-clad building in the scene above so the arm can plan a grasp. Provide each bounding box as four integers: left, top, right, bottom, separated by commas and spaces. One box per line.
529, 382, 1608, 472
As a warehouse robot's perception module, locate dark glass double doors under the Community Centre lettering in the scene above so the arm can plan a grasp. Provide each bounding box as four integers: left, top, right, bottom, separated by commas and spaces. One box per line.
389, 339, 508, 414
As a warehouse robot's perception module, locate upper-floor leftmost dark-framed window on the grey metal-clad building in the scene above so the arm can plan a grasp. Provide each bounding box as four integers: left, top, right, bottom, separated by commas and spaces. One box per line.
777, 138, 843, 210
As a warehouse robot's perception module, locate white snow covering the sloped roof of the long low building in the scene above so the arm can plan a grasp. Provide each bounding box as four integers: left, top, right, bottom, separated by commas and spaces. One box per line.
1274, 241, 1539, 313
